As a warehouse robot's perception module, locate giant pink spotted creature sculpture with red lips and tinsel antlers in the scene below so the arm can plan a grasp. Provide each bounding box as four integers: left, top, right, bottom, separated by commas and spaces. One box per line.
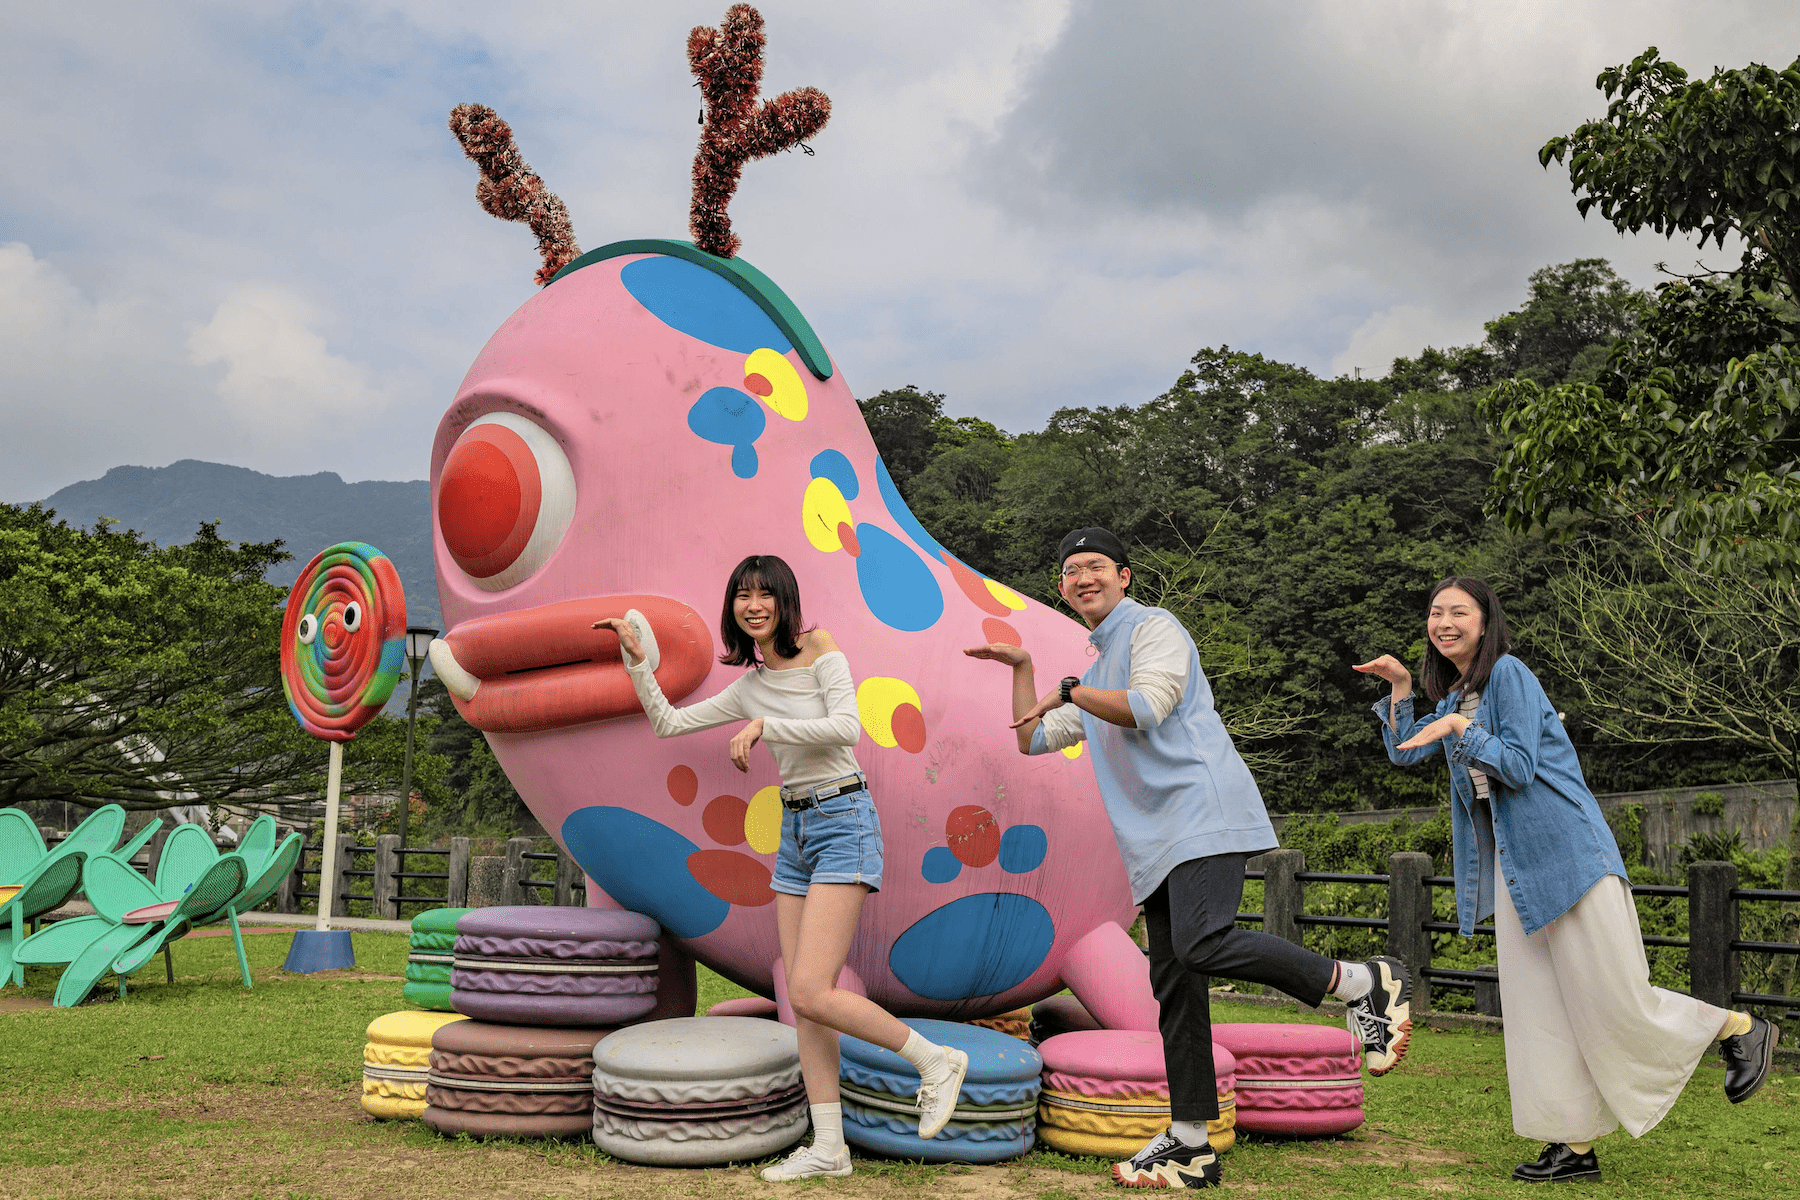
432, 5, 1156, 1027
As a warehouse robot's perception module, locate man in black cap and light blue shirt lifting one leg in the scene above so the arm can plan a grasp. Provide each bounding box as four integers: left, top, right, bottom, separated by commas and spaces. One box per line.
965, 529, 1413, 1187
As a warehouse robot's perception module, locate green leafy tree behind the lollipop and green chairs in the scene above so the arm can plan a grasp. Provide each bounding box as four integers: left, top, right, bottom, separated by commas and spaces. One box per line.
0, 504, 437, 810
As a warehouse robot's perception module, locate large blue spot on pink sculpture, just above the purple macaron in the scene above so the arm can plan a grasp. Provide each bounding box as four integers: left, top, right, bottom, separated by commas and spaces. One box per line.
562, 806, 731, 937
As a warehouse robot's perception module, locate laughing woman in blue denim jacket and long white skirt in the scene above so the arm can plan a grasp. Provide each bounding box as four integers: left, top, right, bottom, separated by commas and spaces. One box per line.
1355, 576, 1780, 1182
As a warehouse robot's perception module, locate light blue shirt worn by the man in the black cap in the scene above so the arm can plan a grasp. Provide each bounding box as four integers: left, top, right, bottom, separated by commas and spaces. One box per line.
1031, 597, 1278, 903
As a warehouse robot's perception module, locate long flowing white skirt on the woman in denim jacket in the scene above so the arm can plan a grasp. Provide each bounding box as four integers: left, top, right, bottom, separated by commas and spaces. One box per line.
1494, 873, 1728, 1142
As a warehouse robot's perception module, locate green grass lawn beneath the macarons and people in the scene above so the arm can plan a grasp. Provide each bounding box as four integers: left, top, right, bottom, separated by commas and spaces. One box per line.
0, 932, 1800, 1200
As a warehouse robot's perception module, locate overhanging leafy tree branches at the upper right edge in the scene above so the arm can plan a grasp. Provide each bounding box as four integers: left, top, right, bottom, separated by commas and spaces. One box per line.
1487, 47, 1800, 579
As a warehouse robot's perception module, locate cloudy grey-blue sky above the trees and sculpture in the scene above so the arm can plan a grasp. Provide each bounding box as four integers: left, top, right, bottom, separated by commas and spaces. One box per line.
0, 0, 1800, 500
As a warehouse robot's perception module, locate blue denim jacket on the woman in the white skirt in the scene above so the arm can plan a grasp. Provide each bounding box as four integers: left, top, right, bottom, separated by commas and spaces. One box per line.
1375, 655, 1631, 937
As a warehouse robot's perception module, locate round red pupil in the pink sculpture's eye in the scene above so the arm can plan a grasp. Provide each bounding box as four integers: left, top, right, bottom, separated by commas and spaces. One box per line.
437, 425, 544, 579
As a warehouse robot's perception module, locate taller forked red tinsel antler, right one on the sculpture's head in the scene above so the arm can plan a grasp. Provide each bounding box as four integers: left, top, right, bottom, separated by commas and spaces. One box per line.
687, 4, 832, 259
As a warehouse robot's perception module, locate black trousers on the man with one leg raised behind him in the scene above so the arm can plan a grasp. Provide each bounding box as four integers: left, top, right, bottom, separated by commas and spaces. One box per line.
1143, 855, 1337, 1121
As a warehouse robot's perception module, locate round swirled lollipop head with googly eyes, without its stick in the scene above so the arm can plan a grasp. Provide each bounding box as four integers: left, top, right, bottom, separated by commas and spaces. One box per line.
281, 542, 407, 741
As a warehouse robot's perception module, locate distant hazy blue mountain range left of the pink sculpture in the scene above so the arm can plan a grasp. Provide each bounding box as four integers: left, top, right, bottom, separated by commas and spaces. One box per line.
43, 459, 443, 628
